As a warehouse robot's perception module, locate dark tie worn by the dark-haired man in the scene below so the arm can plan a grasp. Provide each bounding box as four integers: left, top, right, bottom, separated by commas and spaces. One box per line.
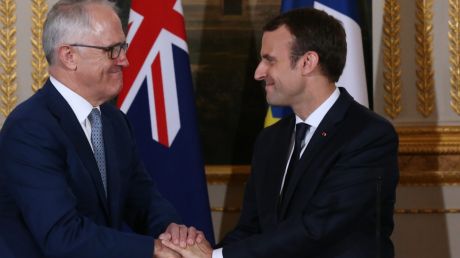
279, 123, 310, 204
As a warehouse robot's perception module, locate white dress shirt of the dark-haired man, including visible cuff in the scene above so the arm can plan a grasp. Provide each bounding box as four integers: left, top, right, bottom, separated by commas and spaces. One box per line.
212, 88, 340, 258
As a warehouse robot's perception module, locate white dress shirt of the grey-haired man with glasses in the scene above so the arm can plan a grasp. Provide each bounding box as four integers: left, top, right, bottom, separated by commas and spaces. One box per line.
50, 76, 99, 151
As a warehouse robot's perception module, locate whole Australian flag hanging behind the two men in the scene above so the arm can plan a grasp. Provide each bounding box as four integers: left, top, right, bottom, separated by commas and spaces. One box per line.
117, 0, 214, 243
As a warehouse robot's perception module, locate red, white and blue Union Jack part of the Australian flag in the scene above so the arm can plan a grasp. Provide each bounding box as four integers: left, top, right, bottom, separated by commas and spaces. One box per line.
118, 0, 188, 147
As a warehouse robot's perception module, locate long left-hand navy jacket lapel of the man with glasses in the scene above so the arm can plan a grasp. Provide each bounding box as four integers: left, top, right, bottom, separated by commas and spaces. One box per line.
42, 80, 110, 218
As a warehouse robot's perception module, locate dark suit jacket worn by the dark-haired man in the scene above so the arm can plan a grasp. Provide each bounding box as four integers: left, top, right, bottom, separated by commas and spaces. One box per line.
220, 88, 399, 258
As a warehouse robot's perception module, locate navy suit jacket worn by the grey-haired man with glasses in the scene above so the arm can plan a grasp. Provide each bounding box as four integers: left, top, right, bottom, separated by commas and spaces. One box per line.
0, 81, 178, 258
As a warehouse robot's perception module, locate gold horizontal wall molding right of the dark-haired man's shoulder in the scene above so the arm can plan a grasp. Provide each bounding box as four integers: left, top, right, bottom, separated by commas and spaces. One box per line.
396, 126, 460, 154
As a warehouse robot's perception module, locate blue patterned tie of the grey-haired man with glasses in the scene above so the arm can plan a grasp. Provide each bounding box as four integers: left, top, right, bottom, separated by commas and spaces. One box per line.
88, 108, 107, 196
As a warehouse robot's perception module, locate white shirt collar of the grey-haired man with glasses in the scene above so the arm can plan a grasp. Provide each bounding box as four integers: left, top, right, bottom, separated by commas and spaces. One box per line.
50, 76, 99, 124
